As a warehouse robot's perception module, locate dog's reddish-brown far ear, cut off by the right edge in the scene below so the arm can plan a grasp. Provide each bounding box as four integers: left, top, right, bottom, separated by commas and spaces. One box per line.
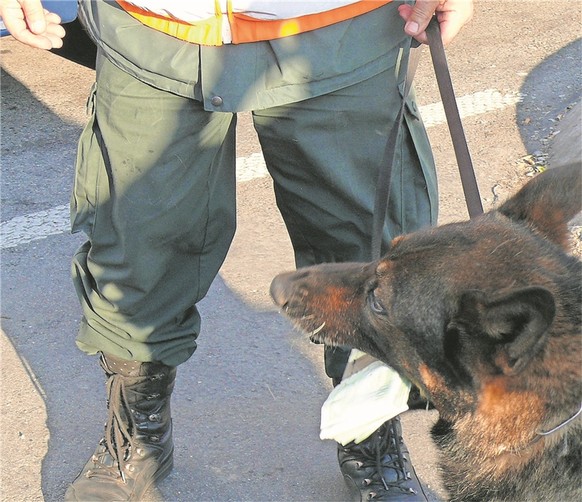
499, 162, 582, 249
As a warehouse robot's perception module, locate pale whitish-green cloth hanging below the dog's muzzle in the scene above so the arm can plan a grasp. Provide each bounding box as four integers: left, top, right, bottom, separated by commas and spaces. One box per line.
319, 353, 410, 445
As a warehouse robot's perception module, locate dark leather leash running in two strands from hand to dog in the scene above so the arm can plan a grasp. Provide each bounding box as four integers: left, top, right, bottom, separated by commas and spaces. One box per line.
372, 17, 483, 260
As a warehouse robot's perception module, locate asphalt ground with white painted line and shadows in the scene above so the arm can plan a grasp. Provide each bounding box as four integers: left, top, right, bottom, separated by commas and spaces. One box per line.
0, 0, 582, 501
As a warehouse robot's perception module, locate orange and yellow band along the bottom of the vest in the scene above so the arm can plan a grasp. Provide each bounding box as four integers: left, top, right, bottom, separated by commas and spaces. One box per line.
117, 0, 392, 46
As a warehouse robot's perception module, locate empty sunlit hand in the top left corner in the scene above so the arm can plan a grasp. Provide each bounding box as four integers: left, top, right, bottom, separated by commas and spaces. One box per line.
0, 0, 65, 50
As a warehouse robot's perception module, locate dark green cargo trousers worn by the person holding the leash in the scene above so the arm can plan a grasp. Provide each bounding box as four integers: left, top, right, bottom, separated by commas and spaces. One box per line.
72, 56, 437, 368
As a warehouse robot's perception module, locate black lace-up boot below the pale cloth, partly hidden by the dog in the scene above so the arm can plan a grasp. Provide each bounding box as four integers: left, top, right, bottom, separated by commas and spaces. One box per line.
338, 417, 428, 502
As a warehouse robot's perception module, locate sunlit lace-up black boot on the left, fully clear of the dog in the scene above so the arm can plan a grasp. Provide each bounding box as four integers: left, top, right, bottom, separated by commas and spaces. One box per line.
65, 354, 176, 501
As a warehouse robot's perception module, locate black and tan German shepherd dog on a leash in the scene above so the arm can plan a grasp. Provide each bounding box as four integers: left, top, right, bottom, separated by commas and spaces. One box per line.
271, 164, 582, 502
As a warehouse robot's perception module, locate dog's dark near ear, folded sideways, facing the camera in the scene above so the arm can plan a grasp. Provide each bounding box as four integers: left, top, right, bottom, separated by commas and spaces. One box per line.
458, 286, 556, 375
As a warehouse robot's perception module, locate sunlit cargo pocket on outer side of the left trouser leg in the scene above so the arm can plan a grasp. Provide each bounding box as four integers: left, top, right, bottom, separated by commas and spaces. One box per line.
71, 83, 104, 236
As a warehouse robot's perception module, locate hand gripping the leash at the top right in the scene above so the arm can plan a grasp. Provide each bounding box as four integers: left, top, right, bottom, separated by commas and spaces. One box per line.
398, 0, 473, 45
